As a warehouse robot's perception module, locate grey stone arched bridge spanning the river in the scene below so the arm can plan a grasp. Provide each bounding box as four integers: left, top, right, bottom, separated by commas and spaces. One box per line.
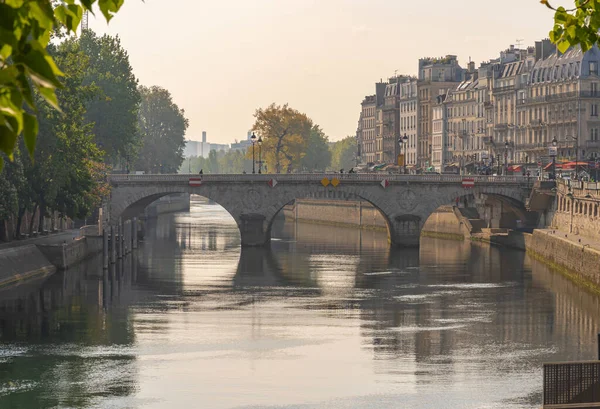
108, 173, 533, 246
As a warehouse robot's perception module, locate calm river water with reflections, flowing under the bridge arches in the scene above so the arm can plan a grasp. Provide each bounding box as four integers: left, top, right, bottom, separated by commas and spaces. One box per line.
0, 198, 600, 409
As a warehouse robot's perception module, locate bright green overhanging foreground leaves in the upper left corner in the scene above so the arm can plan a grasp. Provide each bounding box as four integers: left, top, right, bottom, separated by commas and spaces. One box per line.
0, 0, 124, 169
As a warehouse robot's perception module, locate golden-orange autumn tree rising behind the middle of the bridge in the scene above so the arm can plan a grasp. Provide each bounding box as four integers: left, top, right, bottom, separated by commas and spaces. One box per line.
250, 104, 313, 173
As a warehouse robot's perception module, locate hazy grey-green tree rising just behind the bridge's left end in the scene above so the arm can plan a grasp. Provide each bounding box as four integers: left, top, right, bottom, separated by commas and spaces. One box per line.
136, 86, 188, 173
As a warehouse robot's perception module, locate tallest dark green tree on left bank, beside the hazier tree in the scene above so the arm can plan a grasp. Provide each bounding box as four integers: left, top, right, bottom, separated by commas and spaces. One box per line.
79, 30, 141, 167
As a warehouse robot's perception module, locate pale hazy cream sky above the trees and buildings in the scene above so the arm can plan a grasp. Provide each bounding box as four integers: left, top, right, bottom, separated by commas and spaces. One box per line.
90, 0, 556, 143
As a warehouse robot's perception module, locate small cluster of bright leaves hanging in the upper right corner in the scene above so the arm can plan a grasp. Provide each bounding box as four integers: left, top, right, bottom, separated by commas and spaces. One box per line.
540, 0, 600, 53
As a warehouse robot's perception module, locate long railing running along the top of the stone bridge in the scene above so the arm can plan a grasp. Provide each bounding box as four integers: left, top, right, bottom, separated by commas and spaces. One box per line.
110, 173, 535, 185
